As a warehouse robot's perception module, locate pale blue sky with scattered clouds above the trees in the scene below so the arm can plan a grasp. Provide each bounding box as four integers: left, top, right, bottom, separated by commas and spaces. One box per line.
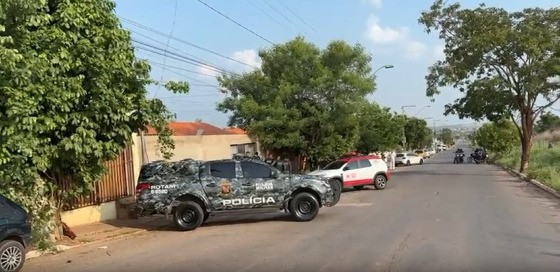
116, 0, 558, 127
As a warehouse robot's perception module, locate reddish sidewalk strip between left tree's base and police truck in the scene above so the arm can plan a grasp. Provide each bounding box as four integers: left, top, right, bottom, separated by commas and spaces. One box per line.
27, 216, 171, 259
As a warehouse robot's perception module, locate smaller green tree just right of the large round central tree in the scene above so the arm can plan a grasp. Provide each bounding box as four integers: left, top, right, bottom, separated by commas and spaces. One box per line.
356, 102, 404, 154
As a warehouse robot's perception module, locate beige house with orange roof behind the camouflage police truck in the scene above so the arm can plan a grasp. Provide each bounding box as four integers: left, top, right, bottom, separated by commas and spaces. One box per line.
138, 122, 261, 163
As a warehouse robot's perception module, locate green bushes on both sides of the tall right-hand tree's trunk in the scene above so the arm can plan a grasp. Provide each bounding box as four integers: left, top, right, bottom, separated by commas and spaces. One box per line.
497, 142, 560, 191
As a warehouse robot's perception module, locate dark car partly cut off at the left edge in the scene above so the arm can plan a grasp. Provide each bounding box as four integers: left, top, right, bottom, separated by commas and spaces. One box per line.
0, 195, 31, 272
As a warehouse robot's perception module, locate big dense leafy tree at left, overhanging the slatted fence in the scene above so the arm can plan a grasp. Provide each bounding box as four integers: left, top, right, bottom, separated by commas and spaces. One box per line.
0, 0, 188, 249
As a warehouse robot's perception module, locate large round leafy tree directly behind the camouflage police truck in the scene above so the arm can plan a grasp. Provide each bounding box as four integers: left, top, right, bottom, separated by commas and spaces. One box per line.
218, 37, 375, 169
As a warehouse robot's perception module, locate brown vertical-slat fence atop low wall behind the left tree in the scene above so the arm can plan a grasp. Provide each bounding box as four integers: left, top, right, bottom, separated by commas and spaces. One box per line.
59, 147, 135, 211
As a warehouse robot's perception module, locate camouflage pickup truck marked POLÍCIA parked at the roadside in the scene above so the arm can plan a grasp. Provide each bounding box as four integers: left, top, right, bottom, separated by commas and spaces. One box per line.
136, 159, 342, 230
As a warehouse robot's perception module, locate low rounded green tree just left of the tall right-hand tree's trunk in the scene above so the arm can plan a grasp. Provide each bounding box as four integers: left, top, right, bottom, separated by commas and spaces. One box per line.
475, 120, 519, 154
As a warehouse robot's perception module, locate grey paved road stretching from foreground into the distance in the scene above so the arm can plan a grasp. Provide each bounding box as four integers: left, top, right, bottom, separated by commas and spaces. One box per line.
23, 148, 560, 272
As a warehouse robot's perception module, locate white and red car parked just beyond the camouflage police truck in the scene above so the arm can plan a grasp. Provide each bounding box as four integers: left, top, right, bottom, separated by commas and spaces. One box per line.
309, 156, 390, 190
